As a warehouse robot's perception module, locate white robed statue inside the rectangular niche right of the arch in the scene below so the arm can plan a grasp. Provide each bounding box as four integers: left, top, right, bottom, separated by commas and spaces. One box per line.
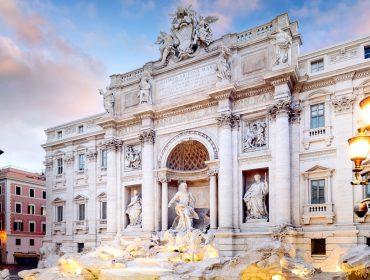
243, 174, 268, 220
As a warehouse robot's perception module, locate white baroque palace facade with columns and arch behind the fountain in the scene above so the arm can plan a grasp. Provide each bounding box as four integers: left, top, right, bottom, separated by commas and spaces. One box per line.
43, 7, 370, 270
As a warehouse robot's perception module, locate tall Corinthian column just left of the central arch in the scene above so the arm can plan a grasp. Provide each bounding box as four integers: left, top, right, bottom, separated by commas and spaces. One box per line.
139, 129, 155, 231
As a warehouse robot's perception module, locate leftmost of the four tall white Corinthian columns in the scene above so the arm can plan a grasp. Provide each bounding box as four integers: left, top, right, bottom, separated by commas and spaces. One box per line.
105, 138, 122, 234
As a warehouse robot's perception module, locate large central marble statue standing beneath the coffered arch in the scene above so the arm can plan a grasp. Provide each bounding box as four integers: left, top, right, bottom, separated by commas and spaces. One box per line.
168, 182, 199, 232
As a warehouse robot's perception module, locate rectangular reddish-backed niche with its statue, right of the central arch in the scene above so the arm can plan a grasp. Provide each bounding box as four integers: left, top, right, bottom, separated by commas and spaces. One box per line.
243, 168, 269, 223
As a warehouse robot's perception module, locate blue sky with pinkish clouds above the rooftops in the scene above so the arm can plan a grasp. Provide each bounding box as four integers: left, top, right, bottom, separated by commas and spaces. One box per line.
0, 0, 370, 172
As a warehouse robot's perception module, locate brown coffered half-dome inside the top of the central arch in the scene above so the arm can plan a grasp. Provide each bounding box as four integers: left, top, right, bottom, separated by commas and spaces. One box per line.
166, 140, 209, 171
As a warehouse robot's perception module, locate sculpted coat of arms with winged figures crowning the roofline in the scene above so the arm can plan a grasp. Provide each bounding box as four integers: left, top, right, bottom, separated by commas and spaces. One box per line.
156, 6, 218, 64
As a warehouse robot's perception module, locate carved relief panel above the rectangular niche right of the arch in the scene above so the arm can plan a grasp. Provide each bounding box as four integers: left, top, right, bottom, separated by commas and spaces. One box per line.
242, 120, 267, 152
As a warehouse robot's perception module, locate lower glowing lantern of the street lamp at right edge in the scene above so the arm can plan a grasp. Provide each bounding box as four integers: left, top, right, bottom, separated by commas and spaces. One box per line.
348, 132, 370, 172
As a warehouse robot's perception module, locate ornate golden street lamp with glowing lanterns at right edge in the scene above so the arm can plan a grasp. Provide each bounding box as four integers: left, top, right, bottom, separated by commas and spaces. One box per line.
348, 96, 370, 218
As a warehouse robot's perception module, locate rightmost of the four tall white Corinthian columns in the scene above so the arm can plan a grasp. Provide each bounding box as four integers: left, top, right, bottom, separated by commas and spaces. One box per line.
270, 98, 291, 224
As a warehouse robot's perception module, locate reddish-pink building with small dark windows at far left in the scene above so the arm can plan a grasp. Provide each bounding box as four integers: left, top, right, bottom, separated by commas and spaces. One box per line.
0, 167, 46, 264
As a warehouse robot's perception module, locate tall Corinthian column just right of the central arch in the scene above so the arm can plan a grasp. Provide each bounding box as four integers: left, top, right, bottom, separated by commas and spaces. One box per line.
217, 113, 235, 230
